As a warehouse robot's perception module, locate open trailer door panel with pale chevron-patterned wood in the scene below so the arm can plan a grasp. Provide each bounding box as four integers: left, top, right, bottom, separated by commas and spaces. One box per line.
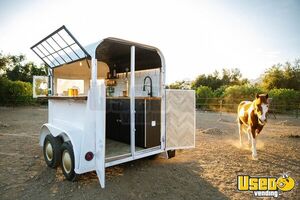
166, 90, 196, 149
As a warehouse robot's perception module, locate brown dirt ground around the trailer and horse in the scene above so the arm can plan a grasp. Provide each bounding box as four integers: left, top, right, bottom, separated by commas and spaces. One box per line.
0, 107, 300, 200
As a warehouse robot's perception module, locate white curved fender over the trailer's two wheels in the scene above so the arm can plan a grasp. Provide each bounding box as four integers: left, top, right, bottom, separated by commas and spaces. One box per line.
40, 123, 82, 171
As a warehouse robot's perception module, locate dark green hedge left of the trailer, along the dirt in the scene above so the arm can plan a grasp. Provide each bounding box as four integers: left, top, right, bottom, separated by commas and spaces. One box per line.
0, 77, 34, 105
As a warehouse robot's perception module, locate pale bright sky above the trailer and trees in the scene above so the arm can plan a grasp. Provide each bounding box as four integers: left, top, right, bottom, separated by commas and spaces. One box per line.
0, 0, 300, 83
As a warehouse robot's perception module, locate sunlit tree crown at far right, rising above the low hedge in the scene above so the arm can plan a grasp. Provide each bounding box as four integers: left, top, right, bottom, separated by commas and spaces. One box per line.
261, 59, 300, 90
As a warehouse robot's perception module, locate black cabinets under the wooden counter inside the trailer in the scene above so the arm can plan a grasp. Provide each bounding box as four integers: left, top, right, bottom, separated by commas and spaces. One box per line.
106, 99, 161, 148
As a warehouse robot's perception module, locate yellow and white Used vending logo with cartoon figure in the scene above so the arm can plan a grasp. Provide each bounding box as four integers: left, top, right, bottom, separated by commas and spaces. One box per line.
237, 173, 296, 197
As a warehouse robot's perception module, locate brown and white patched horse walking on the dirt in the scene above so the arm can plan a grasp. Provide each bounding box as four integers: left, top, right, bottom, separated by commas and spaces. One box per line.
238, 94, 269, 159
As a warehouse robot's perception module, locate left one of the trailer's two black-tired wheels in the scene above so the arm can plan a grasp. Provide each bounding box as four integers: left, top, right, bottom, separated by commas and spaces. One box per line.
43, 135, 62, 168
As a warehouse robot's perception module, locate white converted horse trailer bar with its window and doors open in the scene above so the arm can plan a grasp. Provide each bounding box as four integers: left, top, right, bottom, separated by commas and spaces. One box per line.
31, 26, 195, 188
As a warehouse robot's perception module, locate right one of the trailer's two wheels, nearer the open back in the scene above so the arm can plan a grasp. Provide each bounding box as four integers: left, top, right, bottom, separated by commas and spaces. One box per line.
61, 142, 77, 181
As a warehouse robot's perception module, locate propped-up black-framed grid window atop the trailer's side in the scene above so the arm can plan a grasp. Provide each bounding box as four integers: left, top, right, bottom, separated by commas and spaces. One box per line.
31, 26, 91, 68
